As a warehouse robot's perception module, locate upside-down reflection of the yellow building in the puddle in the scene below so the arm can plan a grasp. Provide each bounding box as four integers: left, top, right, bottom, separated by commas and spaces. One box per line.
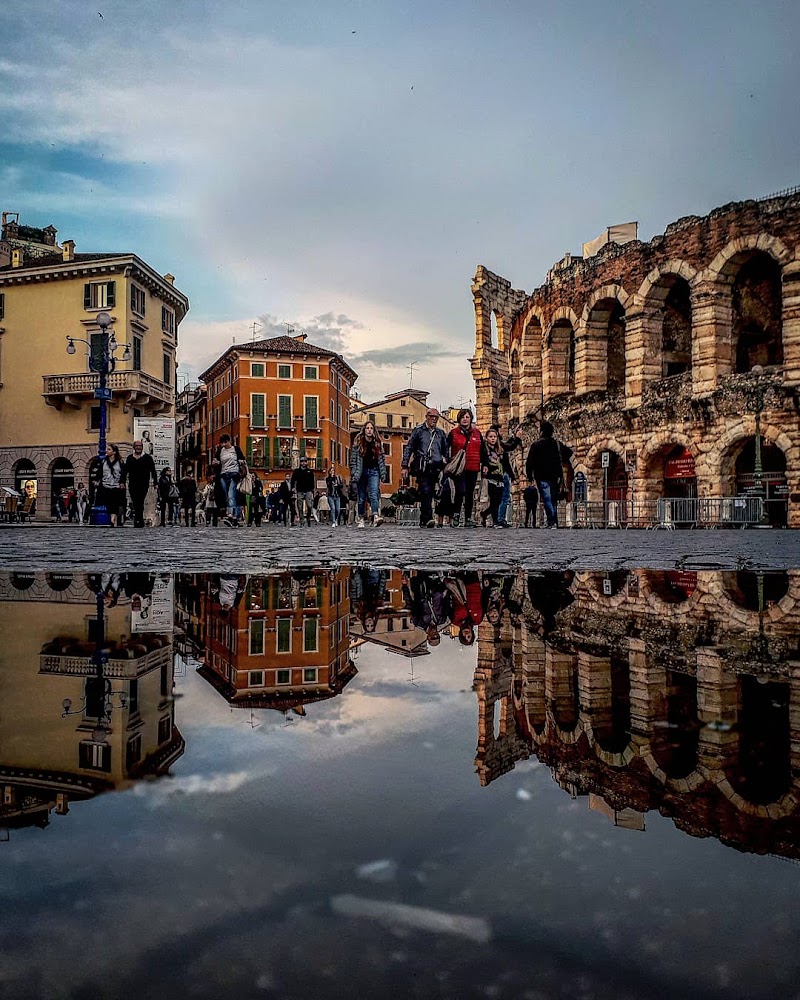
0, 573, 184, 830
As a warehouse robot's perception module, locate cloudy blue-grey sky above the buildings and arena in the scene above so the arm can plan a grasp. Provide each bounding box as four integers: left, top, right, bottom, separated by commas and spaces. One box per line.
0, 0, 800, 404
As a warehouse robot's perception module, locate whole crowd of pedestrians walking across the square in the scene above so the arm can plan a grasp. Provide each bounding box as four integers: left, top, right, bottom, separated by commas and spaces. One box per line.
62, 408, 572, 528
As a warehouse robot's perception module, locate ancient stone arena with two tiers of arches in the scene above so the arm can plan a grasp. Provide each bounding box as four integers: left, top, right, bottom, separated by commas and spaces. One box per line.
472, 191, 800, 527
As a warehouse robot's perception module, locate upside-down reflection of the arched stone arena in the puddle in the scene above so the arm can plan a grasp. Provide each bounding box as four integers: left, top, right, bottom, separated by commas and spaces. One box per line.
475, 572, 800, 858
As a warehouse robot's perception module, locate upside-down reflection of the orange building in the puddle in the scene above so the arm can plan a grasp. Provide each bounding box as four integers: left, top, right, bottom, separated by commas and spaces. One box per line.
192, 570, 356, 714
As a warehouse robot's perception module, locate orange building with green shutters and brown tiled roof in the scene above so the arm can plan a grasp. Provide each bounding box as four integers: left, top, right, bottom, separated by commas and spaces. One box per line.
200, 334, 358, 483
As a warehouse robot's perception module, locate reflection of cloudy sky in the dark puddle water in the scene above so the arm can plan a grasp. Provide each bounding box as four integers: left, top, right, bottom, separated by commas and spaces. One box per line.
0, 584, 800, 1000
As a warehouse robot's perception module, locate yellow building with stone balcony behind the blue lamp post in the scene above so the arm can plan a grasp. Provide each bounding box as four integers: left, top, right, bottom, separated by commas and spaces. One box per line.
0, 212, 189, 519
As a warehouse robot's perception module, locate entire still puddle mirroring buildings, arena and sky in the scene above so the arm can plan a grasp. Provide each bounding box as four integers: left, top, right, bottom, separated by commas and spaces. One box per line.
0, 568, 800, 1000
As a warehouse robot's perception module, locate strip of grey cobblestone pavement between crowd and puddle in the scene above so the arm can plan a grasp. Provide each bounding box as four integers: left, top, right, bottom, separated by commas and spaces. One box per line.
0, 524, 800, 573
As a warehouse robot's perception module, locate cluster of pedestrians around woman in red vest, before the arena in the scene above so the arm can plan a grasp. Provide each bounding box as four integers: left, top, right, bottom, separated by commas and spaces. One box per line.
402, 407, 572, 528
